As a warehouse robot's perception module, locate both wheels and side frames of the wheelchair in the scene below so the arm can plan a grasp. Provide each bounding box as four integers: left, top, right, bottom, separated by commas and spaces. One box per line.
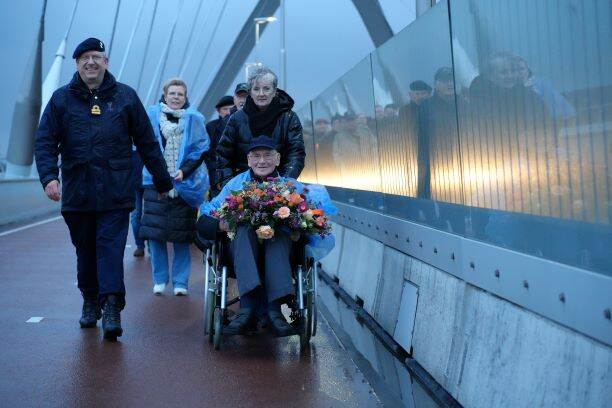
198, 234, 318, 350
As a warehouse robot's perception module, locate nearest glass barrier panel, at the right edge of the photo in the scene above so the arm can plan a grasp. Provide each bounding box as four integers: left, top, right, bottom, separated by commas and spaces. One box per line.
450, 0, 612, 273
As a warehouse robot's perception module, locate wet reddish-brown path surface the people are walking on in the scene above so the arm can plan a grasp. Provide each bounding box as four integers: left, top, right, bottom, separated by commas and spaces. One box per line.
0, 220, 382, 408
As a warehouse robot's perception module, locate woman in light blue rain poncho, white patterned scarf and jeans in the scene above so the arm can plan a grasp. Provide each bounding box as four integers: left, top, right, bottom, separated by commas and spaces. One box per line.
140, 78, 210, 296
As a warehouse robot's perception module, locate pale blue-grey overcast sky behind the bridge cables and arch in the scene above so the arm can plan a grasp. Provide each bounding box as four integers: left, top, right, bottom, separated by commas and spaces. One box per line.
0, 0, 415, 157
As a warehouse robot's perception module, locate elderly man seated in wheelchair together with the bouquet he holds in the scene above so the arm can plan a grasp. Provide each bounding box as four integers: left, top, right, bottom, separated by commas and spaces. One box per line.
198, 135, 335, 337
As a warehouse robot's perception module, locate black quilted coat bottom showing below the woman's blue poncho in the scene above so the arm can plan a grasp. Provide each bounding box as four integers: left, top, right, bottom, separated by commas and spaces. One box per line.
139, 187, 198, 243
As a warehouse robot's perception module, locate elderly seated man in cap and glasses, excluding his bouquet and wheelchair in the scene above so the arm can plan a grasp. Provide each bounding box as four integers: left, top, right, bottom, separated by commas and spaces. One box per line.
198, 136, 335, 337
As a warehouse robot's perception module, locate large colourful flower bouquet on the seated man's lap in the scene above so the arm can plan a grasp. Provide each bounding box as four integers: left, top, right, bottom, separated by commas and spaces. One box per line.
211, 178, 331, 240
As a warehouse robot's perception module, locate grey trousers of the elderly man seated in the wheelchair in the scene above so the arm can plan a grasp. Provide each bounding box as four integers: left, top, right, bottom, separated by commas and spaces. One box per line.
230, 226, 294, 302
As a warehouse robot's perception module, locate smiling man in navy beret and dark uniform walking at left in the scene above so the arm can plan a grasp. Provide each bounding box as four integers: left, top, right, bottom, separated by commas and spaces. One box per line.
35, 38, 172, 341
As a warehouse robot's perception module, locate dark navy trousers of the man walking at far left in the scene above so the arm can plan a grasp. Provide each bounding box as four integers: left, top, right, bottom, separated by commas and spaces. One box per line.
62, 210, 130, 306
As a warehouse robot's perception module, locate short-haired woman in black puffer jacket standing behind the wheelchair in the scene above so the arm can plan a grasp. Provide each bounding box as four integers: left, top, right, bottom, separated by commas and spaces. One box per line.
217, 68, 306, 185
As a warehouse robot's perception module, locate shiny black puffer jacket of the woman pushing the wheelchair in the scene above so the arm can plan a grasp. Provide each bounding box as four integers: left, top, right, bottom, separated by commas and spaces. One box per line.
217, 89, 306, 184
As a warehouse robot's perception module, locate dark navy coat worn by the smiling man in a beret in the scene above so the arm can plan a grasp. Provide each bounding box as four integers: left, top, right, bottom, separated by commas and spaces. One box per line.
35, 71, 172, 211
